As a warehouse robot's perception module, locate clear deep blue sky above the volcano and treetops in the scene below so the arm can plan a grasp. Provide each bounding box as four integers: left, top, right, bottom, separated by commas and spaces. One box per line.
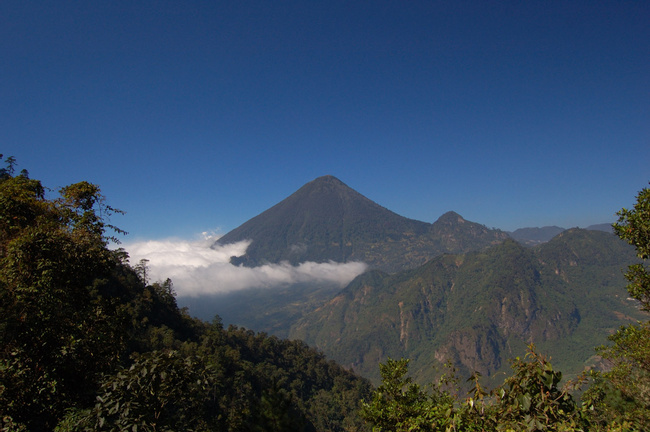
0, 0, 650, 239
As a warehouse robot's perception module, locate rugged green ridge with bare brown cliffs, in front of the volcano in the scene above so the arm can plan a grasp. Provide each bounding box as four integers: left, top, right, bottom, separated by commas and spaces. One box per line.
290, 229, 642, 381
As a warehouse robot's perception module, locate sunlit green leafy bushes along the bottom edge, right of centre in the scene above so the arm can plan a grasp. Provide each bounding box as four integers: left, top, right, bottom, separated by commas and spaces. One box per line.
362, 346, 588, 432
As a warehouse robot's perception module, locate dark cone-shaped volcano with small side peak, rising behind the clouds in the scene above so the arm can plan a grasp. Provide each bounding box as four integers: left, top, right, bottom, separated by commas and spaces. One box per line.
217, 176, 507, 272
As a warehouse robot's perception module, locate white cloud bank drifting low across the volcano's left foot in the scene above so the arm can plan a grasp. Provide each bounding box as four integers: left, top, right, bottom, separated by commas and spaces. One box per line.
122, 234, 367, 297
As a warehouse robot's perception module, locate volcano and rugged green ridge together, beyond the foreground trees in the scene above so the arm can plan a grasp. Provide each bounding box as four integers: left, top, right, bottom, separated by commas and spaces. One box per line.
190, 176, 641, 380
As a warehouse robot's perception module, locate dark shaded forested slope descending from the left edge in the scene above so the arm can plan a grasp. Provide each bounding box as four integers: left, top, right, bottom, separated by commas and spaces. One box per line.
0, 162, 370, 432
